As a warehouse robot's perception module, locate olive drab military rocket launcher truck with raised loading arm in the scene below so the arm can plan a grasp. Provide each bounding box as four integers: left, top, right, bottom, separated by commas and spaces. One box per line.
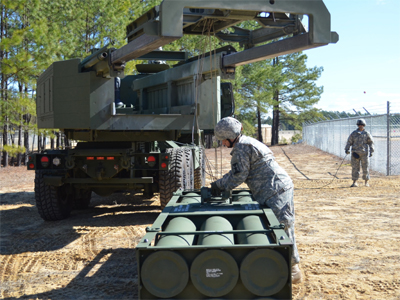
28, 0, 338, 220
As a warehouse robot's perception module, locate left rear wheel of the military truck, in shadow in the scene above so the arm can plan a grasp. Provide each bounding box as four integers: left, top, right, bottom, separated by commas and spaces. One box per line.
35, 171, 72, 221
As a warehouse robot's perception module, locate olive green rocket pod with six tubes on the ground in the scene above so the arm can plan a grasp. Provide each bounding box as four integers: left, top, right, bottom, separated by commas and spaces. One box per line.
136, 190, 293, 299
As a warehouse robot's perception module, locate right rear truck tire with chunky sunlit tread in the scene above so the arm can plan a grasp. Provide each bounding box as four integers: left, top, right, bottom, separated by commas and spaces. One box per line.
159, 148, 194, 209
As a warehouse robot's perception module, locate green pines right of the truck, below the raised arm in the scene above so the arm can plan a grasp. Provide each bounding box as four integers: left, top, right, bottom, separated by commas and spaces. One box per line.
236, 52, 323, 145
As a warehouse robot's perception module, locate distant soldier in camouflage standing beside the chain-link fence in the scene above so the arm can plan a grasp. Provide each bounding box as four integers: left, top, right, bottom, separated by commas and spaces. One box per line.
344, 119, 374, 187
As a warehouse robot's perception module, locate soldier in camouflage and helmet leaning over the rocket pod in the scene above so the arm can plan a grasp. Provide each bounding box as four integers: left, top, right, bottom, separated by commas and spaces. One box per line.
211, 117, 302, 283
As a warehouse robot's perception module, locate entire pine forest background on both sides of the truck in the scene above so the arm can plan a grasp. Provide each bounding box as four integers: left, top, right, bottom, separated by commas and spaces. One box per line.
0, 0, 368, 166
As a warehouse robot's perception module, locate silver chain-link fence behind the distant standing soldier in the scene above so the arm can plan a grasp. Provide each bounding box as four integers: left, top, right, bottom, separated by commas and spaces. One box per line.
303, 103, 400, 175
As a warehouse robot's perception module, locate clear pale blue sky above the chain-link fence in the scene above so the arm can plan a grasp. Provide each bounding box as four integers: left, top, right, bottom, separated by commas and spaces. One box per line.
304, 0, 400, 114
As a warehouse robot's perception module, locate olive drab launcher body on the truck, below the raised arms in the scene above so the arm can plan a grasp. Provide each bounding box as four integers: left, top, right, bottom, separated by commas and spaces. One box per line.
38, 52, 226, 131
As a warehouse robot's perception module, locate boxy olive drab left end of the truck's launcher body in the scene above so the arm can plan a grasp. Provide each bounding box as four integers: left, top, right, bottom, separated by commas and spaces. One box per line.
37, 59, 114, 129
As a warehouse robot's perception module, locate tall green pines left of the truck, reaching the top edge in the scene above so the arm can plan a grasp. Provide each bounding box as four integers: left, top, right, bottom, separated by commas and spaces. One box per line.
0, 0, 142, 164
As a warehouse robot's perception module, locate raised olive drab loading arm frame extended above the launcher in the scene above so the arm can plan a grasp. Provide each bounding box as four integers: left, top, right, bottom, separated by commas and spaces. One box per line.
110, 0, 339, 70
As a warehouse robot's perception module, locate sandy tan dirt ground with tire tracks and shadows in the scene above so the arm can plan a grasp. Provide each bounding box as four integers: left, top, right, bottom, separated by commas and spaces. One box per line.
0, 144, 400, 299
